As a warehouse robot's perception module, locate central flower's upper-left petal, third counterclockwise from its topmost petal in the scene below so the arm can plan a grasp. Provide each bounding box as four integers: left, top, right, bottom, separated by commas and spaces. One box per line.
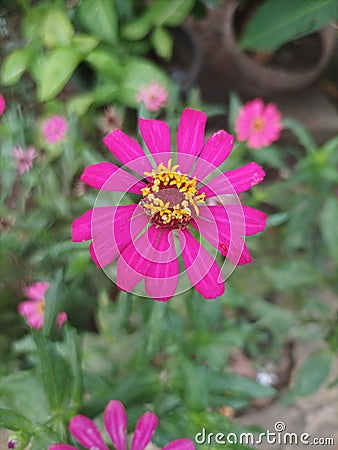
81, 162, 146, 194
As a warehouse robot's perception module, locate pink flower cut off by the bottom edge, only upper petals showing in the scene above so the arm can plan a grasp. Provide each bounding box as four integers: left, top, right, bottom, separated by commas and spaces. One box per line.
48, 400, 195, 450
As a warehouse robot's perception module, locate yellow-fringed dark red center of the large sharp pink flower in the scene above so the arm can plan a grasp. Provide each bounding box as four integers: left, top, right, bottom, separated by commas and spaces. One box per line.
140, 159, 205, 229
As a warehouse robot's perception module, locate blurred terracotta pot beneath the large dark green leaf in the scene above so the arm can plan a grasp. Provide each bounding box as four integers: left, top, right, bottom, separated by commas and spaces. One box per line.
223, 0, 336, 97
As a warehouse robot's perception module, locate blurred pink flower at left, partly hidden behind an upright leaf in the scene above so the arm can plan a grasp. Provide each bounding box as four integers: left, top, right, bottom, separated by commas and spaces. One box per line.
18, 281, 67, 330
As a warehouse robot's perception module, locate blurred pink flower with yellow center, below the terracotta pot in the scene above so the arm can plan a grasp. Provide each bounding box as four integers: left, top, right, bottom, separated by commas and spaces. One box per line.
235, 98, 283, 149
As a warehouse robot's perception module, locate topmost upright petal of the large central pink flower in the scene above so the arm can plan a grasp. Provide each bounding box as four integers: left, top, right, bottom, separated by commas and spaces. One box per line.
177, 108, 207, 173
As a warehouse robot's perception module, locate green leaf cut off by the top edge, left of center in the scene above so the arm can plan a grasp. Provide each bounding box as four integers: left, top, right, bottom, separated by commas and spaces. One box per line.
78, 0, 117, 44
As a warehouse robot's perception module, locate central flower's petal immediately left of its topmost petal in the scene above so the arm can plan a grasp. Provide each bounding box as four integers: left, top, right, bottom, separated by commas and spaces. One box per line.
138, 118, 170, 165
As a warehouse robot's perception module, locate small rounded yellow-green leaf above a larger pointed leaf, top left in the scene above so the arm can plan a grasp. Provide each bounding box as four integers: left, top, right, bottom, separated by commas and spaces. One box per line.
42, 8, 74, 48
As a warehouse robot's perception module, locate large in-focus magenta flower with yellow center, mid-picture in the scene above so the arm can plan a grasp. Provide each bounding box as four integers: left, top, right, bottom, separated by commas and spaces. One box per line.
72, 108, 266, 301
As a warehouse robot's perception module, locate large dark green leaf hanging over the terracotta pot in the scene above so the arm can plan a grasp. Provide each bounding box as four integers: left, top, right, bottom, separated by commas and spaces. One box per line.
239, 0, 338, 51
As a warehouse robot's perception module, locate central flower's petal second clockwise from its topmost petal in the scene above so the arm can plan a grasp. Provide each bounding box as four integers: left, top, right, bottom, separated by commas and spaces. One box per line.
199, 162, 265, 198
